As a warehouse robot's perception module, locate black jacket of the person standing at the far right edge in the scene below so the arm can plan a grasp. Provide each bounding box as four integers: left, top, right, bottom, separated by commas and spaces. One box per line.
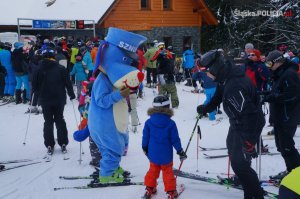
268, 60, 300, 125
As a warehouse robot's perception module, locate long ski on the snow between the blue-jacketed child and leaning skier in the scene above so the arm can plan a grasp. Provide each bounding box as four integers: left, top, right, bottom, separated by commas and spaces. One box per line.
173, 169, 278, 199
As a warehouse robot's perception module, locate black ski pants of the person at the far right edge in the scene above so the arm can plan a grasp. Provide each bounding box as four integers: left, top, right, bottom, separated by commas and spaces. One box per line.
274, 122, 300, 171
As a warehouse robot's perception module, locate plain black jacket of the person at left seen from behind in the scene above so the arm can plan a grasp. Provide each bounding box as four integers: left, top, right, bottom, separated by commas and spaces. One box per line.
32, 59, 75, 106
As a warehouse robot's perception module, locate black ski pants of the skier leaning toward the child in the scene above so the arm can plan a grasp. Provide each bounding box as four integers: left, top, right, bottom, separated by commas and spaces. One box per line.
226, 127, 264, 199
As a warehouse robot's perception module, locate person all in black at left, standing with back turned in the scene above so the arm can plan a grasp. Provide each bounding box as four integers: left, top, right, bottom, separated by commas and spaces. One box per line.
32, 47, 75, 154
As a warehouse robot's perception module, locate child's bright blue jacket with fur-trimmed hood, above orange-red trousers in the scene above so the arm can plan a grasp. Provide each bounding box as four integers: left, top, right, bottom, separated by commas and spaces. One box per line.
142, 108, 182, 165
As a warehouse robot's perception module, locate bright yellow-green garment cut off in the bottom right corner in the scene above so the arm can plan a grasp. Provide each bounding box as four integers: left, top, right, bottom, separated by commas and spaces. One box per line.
280, 166, 300, 195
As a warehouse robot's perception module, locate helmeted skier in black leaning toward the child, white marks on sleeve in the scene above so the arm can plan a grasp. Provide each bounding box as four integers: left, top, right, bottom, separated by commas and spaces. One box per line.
197, 49, 265, 199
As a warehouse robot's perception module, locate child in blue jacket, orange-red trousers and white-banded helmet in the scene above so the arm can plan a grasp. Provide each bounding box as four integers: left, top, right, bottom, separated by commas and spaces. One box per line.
142, 95, 187, 199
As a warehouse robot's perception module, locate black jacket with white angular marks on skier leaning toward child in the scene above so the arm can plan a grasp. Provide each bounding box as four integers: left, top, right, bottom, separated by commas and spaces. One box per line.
205, 61, 264, 143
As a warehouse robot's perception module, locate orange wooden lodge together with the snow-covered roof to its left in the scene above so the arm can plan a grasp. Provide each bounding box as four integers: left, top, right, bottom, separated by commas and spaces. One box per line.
0, 0, 217, 53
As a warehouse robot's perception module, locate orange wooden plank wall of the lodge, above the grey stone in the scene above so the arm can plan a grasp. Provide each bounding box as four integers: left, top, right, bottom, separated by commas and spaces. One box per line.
101, 0, 202, 30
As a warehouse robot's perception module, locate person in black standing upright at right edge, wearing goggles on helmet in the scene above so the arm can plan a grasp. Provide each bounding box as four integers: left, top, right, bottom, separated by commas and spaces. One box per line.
263, 50, 300, 180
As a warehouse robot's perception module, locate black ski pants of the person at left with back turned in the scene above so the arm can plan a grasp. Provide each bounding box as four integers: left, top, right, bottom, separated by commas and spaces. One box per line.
42, 105, 69, 147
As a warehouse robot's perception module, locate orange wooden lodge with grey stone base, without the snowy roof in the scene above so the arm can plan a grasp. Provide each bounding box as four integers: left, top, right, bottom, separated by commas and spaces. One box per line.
98, 0, 217, 53
